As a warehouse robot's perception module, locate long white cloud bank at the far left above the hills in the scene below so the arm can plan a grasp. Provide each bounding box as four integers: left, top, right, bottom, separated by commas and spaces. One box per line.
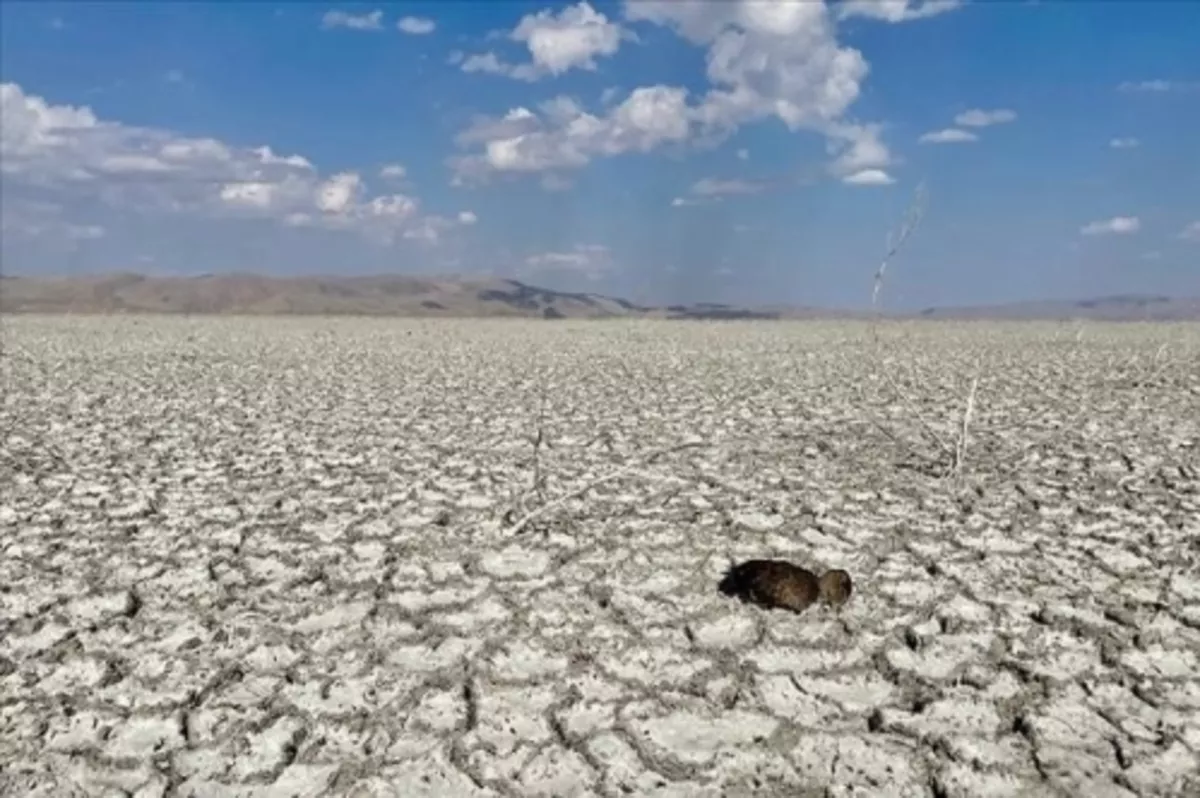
0, 83, 472, 240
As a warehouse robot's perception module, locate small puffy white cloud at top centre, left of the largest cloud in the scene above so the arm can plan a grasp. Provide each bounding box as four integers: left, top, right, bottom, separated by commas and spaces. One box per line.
460, 0, 628, 82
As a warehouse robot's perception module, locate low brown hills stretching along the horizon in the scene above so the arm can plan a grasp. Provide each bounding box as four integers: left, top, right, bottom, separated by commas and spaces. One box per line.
0, 272, 1200, 320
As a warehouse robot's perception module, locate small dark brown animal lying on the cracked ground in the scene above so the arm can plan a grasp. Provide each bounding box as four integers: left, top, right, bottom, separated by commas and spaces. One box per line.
718, 559, 853, 612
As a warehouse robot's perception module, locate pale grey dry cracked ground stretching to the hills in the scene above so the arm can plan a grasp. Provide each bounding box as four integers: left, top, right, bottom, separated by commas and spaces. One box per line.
0, 317, 1200, 798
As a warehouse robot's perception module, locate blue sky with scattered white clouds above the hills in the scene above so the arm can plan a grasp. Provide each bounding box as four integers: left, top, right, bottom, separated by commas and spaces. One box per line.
0, 0, 1200, 307
